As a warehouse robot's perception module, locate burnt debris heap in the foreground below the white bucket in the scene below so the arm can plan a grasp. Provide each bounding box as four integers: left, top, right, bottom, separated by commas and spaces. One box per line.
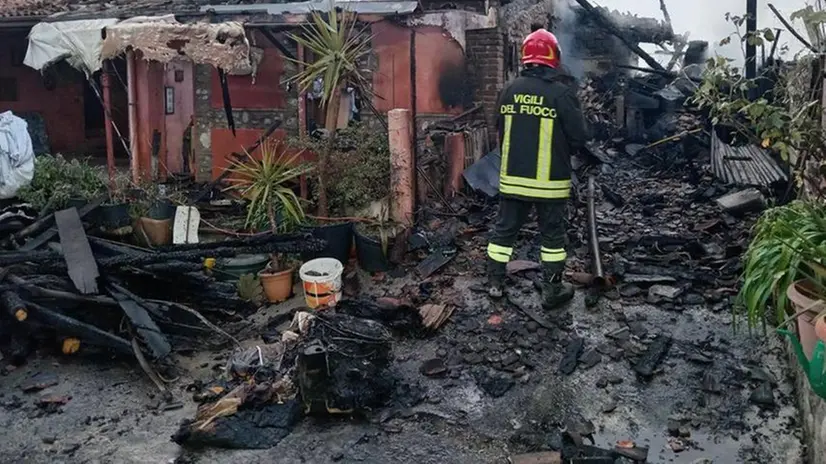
173, 308, 422, 449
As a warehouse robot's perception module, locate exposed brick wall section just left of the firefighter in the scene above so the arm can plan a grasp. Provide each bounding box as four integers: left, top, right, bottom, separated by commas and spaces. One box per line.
466, 29, 505, 144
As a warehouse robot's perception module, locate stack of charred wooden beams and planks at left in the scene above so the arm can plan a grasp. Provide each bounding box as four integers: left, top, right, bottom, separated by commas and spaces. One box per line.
0, 202, 323, 376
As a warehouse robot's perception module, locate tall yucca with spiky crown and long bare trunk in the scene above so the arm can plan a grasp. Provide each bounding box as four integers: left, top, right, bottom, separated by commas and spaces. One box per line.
290, 2, 372, 216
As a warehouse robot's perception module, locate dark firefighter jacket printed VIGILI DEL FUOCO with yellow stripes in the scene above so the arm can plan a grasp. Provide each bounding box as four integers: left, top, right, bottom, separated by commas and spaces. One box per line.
498, 66, 587, 201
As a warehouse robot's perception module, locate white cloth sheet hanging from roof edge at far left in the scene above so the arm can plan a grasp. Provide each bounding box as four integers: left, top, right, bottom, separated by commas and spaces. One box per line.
23, 19, 118, 75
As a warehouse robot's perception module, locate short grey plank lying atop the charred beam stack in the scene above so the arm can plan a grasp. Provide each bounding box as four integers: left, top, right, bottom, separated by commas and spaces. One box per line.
54, 208, 100, 295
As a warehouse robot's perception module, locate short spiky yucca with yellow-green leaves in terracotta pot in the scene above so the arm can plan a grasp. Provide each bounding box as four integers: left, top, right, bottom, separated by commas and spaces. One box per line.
227, 142, 311, 232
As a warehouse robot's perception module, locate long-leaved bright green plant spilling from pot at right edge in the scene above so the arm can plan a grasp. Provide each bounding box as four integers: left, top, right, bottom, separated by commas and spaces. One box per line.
737, 201, 826, 329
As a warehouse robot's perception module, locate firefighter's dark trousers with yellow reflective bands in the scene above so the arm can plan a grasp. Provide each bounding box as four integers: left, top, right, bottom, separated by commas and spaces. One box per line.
488, 198, 568, 279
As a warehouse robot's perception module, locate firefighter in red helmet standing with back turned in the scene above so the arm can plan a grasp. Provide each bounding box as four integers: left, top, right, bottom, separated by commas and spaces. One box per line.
487, 28, 587, 309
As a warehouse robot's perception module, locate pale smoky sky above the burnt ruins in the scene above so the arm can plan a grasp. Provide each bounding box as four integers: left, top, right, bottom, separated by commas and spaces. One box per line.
591, 0, 812, 61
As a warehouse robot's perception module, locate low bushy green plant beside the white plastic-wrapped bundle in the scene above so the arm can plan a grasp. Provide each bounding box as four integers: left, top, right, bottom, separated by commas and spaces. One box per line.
18, 154, 106, 211
